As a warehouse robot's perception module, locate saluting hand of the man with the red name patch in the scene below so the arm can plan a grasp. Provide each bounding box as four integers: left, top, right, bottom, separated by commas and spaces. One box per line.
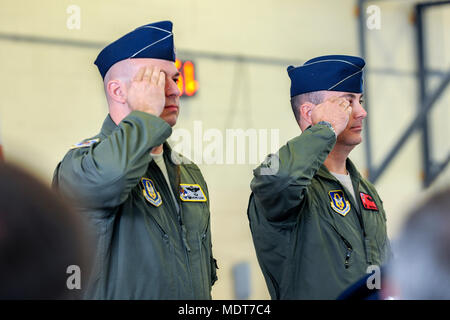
311, 97, 352, 135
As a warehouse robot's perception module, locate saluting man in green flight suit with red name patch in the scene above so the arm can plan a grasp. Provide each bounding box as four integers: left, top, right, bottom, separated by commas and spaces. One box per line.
247, 55, 390, 299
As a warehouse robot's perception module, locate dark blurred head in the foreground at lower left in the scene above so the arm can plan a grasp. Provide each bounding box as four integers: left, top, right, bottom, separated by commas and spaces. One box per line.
0, 163, 91, 300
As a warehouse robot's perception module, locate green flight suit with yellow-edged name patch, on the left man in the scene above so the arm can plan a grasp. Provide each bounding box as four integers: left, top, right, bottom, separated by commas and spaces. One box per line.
53, 111, 217, 299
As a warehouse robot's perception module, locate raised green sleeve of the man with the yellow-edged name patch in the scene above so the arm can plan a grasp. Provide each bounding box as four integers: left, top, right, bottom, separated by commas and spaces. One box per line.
53, 111, 172, 209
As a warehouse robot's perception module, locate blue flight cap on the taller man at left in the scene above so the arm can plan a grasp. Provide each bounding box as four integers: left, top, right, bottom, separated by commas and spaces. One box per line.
94, 21, 175, 78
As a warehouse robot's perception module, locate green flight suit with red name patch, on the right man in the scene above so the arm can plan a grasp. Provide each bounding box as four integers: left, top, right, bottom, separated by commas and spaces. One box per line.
247, 124, 390, 299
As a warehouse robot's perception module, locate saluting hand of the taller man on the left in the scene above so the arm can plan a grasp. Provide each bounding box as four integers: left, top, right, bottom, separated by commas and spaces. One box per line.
127, 66, 166, 117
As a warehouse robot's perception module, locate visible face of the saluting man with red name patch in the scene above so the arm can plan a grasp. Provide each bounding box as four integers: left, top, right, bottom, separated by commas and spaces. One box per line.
323, 91, 367, 146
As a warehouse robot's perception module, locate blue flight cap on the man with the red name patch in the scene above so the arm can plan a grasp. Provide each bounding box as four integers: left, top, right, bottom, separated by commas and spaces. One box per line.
287, 55, 366, 98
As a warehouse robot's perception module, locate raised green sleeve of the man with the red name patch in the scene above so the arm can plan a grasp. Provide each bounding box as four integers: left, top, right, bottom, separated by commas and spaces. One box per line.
250, 124, 336, 222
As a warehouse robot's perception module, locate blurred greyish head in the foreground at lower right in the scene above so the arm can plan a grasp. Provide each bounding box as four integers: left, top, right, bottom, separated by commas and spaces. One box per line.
381, 187, 450, 300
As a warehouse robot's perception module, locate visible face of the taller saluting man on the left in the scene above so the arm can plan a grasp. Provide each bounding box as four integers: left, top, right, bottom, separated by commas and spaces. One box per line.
131, 58, 181, 127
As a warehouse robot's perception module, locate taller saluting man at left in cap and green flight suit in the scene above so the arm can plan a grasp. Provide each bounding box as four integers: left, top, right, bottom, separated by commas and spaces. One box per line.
53, 21, 217, 299
